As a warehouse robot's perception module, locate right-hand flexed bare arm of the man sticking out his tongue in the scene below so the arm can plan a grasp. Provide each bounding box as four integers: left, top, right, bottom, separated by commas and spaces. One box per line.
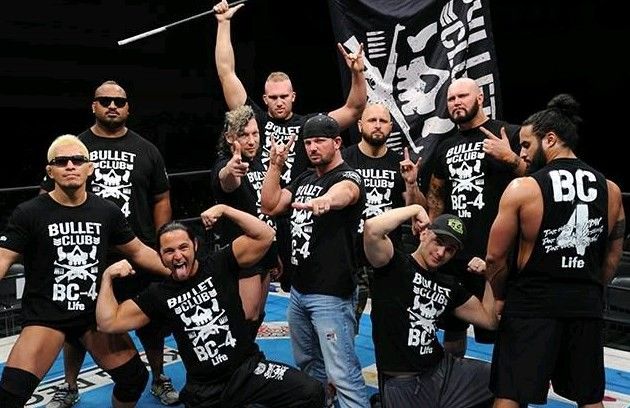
201, 204, 276, 268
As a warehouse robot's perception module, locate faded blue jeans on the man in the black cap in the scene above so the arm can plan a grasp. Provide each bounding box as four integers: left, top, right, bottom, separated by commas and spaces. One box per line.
288, 288, 370, 408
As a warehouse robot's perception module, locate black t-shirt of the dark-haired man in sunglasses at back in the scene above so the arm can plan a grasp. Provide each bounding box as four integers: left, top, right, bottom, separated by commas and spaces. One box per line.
41, 129, 169, 247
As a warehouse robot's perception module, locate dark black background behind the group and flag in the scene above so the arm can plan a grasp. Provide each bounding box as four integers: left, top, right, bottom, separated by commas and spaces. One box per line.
0, 0, 630, 222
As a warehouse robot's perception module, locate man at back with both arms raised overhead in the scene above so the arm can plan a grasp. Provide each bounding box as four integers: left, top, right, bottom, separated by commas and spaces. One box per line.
214, 0, 367, 187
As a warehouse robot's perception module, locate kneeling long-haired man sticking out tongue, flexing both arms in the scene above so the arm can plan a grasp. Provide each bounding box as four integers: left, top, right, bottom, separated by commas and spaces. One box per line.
96, 204, 324, 408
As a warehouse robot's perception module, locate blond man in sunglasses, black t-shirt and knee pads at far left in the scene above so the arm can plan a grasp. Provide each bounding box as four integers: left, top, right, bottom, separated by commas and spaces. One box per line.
0, 135, 168, 408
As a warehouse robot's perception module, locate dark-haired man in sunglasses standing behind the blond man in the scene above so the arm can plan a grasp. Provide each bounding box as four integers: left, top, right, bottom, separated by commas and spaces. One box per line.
42, 81, 178, 408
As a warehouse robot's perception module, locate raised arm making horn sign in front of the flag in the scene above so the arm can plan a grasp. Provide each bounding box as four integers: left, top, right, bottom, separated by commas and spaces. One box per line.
328, 43, 367, 130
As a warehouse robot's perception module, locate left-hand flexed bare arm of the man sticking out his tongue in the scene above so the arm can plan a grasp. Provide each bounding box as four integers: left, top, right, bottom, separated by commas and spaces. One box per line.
96, 260, 150, 333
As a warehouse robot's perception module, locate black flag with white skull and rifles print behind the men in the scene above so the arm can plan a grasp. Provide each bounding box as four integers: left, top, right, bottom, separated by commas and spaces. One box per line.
328, 0, 500, 184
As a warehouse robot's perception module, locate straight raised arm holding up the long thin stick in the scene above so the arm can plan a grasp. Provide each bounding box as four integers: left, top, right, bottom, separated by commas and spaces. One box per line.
214, 0, 247, 110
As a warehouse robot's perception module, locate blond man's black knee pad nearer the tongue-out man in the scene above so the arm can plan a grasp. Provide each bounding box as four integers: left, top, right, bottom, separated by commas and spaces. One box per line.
107, 354, 149, 402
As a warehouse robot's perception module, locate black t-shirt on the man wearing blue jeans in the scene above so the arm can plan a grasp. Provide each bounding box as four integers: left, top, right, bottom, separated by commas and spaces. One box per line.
287, 163, 365, 297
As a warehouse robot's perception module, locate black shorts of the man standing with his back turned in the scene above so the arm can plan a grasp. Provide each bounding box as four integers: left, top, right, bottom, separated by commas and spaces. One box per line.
490, 316, 605, 405
